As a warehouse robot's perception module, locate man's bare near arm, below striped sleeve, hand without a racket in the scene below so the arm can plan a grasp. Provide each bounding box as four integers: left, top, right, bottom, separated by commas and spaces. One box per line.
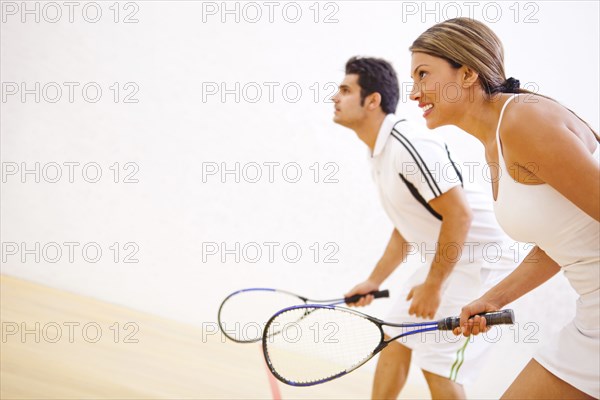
406, 186, 473, 319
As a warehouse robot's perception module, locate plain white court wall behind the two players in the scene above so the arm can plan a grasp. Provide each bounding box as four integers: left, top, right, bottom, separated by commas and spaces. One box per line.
0, 1, 600, 388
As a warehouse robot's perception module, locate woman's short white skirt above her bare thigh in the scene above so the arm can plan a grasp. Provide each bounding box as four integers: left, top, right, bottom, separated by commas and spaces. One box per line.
534, 290, 600, 398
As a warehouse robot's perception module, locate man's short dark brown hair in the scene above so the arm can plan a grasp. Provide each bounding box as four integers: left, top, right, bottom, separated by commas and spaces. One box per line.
346, 57, 400, 114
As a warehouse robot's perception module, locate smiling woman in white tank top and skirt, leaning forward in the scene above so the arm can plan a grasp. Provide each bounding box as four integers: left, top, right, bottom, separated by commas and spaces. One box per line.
410, 18, 600, 399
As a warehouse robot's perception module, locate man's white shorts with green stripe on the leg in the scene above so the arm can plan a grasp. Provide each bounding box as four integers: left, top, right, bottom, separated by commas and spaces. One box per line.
384, 264, 511, 384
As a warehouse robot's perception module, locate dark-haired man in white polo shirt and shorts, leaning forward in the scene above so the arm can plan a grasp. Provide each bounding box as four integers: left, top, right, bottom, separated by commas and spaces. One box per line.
333, 57, 515, 398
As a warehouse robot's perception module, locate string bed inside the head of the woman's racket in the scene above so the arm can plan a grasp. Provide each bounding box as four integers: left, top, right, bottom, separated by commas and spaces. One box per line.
264, 308, 382, 384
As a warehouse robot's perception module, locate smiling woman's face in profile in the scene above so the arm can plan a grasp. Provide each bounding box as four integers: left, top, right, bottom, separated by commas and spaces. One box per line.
410, 52, 469, 129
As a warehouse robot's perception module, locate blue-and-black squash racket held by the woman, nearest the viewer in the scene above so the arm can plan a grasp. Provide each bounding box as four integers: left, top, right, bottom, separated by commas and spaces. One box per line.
262, 304, 514, 386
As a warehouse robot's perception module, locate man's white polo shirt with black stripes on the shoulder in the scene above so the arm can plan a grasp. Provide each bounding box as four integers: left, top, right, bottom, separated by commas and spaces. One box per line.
370, 114, 516, 270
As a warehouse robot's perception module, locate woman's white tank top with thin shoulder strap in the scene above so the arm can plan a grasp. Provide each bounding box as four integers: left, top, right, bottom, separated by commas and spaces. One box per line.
494, 95, 600, 294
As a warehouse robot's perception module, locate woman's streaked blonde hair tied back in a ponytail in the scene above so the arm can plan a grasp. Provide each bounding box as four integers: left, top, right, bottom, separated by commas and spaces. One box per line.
409, 18, 599, 139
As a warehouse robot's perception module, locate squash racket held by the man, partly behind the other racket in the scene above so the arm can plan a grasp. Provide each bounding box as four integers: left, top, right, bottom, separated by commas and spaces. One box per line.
218, 288, 389, 343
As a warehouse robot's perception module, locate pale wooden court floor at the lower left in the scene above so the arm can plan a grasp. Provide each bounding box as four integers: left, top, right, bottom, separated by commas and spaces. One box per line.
0, 275, 428, 399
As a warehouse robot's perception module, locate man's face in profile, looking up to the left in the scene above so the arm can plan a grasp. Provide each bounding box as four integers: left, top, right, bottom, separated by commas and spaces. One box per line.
332, 74, 367, 128
